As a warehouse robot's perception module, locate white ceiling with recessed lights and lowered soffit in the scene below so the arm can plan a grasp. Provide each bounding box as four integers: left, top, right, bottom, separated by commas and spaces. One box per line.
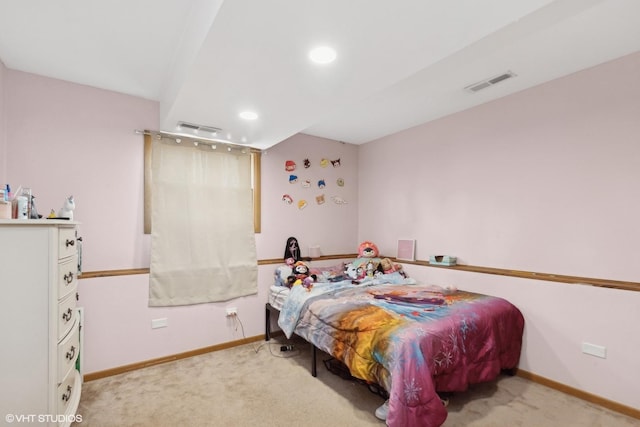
0, 0, 640, 148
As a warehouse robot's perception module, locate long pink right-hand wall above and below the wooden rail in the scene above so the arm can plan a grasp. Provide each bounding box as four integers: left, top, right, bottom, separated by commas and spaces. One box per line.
358, 53, 640, 408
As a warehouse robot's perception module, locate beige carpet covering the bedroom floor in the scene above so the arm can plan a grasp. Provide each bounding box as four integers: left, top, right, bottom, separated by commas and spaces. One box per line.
77, 337, 640, 427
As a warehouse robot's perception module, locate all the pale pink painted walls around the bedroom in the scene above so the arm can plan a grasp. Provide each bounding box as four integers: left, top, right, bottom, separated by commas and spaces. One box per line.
0, 54, 640, 407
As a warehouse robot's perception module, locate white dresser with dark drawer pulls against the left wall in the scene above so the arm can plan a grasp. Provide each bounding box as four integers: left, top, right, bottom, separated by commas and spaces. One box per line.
0, 219, 82, 426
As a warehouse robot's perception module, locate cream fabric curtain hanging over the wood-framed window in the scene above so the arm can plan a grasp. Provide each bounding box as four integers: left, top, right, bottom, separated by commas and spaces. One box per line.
149, 139, 258, 306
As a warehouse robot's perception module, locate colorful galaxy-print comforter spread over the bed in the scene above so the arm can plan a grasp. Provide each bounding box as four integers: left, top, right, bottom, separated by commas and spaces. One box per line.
278, 281, 524, 427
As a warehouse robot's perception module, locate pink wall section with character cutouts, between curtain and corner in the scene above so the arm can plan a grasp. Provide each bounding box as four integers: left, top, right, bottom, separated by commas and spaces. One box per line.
256, 134, 358, 259
